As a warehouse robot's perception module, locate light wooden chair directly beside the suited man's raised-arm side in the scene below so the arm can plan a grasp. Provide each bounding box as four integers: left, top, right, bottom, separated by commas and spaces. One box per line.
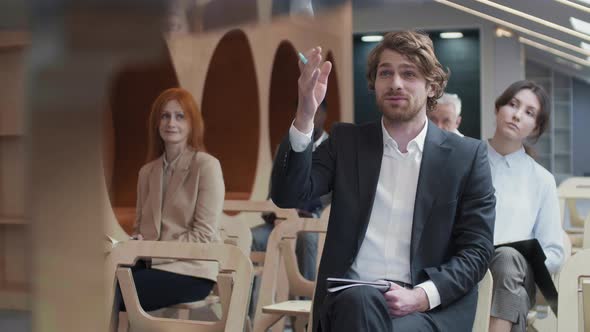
254, 217, 328, 332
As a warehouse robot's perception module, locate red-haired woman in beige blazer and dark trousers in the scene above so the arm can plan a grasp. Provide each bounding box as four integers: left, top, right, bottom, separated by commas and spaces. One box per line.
119, 88, 225, 311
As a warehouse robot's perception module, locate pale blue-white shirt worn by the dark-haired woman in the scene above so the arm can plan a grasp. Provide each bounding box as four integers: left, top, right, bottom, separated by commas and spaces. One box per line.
488, 142, 565, 273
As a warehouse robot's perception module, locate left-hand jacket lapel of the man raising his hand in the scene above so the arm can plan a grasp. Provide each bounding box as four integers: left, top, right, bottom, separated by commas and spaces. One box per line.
355, 119, 383, 251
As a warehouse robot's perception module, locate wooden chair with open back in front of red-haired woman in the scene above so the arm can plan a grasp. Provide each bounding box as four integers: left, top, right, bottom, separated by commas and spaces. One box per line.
107, 241, 252, 332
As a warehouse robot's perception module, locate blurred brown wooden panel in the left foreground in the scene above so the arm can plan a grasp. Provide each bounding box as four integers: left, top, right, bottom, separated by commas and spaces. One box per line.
26, 0, 166, 332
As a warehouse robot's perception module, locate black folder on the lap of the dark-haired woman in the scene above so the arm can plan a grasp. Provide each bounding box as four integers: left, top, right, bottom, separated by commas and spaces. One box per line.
495, 239, 557, 316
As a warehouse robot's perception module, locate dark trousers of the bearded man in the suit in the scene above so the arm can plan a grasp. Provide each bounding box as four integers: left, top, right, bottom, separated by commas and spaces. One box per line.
320, 286, 438, 332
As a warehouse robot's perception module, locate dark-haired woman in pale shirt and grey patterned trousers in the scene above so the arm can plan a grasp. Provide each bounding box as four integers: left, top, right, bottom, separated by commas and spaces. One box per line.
488, 81, 564, 332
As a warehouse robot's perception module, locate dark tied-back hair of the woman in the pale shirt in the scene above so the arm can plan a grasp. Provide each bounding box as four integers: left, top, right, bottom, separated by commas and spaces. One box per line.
495, 80, 551, 157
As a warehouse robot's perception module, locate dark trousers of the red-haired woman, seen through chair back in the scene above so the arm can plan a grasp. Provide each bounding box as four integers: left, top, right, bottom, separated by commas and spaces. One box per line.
115, 261, 215, 311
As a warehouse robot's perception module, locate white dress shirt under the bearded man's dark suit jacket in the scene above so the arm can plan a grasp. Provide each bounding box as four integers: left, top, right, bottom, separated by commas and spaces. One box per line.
289, 117, 440, 309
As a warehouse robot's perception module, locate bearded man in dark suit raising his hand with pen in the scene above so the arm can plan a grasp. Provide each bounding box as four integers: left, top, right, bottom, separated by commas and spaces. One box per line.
271, 31, 495, 332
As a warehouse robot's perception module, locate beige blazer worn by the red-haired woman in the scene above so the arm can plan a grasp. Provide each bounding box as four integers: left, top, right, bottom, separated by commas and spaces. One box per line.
134, 149, 225, 280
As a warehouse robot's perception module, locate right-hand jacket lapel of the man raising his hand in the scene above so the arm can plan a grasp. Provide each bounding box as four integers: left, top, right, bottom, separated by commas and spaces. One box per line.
410, 121, 450, 265
